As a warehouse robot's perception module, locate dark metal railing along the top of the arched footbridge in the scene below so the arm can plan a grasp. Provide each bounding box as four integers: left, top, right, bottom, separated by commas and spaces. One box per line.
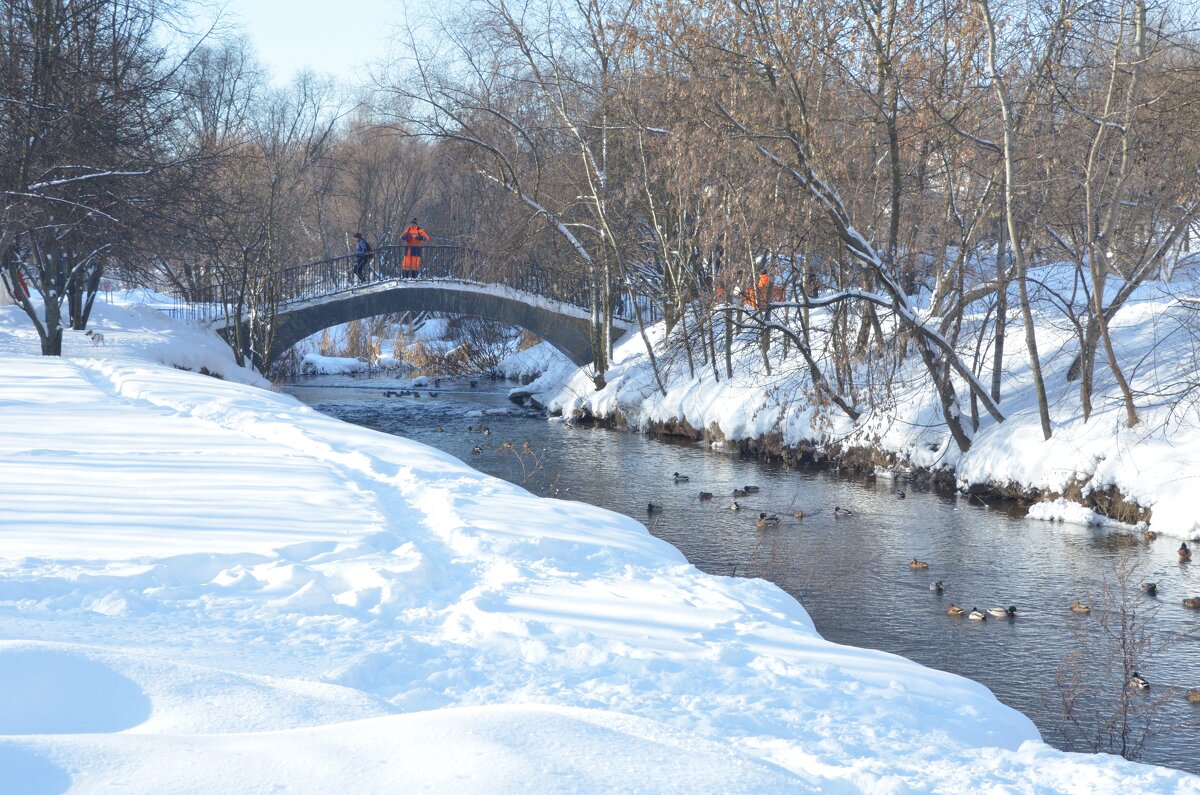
172, 245, 658, 322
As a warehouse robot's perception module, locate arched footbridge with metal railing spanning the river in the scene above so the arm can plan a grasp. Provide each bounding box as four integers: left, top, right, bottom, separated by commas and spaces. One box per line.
182, 245, 650, 366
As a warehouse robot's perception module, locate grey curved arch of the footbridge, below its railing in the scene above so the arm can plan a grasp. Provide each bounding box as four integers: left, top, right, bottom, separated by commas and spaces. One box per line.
225, 279, 629, 366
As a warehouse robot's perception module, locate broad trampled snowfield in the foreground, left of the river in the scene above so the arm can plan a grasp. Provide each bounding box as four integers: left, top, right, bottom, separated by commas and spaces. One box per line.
0, 297, 1200, 794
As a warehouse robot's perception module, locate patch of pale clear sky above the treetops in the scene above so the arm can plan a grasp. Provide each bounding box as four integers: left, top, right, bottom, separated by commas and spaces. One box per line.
213, 0, 425, 85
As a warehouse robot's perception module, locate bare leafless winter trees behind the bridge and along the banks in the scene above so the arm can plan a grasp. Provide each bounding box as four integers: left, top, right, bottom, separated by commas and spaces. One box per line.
0, 0, 1200, 449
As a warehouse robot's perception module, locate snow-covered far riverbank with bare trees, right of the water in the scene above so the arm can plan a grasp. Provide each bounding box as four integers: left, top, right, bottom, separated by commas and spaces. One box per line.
512, 269, 1200, 539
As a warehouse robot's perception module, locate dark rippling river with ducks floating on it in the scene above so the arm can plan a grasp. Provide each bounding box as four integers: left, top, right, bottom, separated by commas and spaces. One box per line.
288, 377, 1200, 772
